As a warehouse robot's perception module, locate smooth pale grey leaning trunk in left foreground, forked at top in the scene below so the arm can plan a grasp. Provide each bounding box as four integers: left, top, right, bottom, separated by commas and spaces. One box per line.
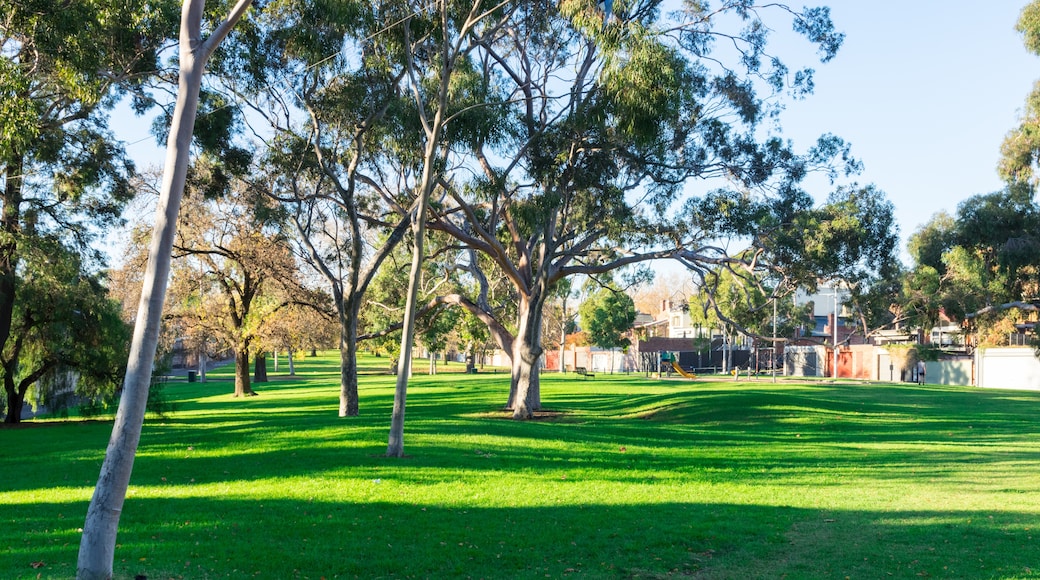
76, 0, 251, 580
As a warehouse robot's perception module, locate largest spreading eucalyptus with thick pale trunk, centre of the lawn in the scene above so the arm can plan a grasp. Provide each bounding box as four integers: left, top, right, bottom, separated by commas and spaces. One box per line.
431, 0, 848, 419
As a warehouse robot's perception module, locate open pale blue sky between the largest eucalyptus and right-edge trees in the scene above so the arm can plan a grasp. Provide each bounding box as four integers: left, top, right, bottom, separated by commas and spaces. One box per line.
778, 0, 1040, 256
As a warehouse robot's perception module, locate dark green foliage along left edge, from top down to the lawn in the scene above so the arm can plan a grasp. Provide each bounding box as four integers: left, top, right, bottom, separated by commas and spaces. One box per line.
0, 0, 172, 420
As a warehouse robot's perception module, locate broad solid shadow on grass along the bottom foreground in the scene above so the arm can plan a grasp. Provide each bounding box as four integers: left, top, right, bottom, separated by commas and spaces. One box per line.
3, 494, 1040, 578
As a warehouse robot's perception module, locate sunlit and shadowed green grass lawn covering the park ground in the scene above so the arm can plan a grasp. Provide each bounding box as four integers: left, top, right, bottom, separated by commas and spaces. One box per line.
0, 353, 1040, 580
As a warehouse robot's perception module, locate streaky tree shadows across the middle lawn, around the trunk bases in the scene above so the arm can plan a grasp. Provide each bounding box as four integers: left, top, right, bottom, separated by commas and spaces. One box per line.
8, 376, 1040, 491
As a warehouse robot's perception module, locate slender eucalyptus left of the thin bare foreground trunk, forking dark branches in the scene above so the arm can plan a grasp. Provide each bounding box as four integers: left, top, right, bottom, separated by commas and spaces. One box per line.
233, 0, 421, 417
